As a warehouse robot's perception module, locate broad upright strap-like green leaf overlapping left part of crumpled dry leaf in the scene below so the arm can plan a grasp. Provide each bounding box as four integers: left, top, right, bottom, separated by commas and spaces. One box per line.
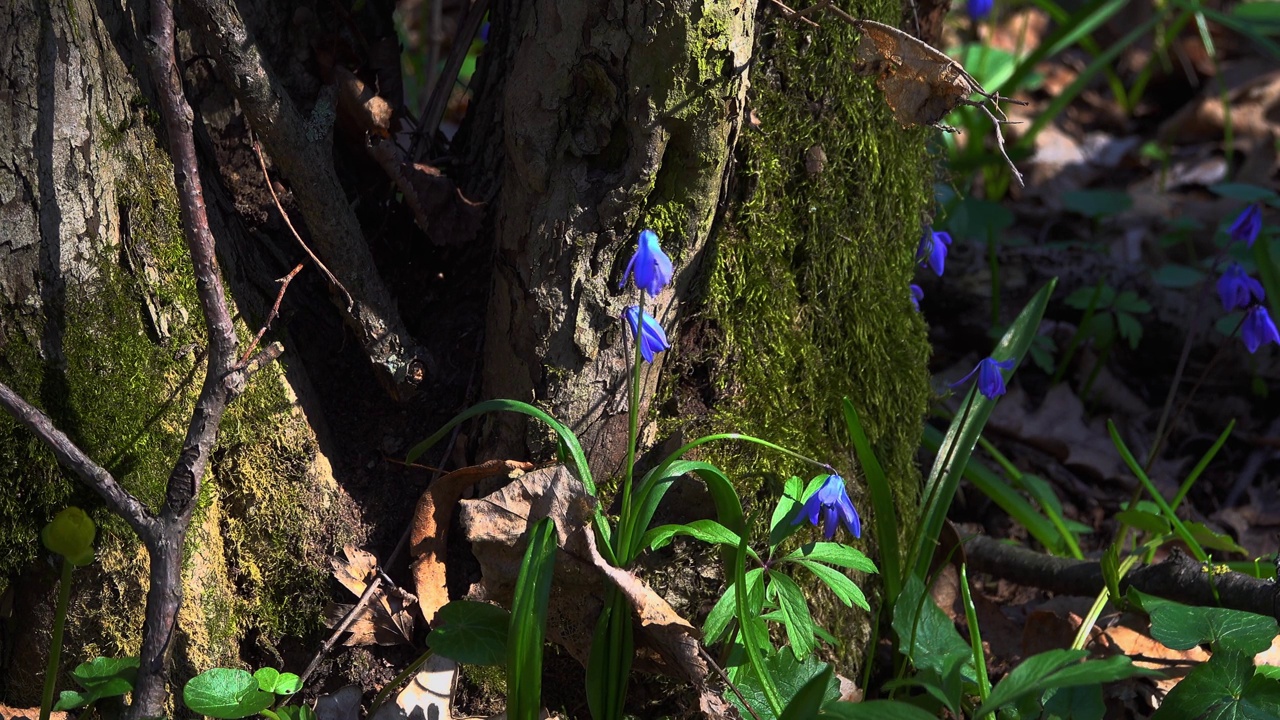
507, 518, 558, 720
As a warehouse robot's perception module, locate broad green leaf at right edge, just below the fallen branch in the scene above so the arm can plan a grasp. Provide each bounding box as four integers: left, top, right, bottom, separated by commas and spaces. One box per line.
1129, 588, 1277, 656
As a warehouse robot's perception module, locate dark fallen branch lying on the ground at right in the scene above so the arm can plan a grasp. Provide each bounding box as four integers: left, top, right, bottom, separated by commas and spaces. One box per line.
964, 536, 1280, 620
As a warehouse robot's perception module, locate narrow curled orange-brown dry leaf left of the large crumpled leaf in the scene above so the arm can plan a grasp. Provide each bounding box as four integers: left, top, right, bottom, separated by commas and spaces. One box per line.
408, 460, 532, 623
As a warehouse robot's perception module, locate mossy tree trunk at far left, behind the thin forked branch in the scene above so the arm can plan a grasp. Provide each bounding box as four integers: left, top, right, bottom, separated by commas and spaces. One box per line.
0, 0, 353, 706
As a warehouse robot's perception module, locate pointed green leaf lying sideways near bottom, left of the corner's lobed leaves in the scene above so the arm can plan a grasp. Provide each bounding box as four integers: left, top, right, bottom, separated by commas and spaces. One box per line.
974, 648, 1155, 717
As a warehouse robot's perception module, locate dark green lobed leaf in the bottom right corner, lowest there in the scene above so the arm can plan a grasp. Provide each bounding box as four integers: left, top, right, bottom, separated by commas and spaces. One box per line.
1152, 652, 1280, 720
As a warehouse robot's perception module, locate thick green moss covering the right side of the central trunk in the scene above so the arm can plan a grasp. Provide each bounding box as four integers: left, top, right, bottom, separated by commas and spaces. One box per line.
708, 3, 933, 652
